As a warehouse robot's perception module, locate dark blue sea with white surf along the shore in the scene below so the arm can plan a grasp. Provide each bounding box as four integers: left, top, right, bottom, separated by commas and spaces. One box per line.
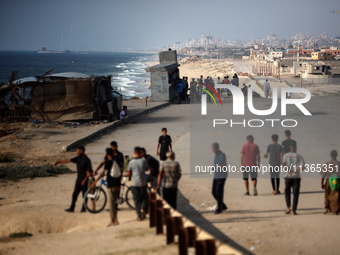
0, 51, 158, 99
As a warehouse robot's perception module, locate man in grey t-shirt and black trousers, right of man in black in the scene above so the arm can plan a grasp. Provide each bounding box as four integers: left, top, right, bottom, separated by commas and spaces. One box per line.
282, 144, 305, 215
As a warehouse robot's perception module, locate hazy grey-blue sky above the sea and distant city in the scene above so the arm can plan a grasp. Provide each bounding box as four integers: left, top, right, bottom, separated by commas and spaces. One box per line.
0, 0, 340, 50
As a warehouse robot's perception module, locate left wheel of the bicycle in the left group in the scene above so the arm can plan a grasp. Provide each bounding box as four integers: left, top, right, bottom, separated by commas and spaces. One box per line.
84, 187, 107, 213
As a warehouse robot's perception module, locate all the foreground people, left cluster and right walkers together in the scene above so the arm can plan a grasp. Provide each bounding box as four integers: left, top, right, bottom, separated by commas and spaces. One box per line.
53, 120, 340, 226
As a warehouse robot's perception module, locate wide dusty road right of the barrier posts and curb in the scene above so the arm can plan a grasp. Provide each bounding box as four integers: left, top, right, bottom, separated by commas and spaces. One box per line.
83, 97, 340, 254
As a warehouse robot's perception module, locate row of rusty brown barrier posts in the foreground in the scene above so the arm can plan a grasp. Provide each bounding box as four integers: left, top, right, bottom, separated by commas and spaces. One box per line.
149, 191, 242, 255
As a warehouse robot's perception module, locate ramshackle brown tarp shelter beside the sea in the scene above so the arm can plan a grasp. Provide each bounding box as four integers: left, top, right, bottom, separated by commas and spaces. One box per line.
0, 73, 122, 122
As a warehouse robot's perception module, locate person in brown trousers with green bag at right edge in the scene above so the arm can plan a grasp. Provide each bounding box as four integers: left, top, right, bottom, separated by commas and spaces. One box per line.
321, 150, 340, 214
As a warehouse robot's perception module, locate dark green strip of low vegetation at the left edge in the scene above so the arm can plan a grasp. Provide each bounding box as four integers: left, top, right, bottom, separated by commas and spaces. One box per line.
0, 165, 73, 181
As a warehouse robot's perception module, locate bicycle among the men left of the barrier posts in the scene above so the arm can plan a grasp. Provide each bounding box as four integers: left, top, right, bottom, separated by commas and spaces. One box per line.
84, 175, 135, 213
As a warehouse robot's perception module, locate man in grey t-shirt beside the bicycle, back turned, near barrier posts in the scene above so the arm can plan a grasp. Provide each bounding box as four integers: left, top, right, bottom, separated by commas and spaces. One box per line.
127, 147, 149, 221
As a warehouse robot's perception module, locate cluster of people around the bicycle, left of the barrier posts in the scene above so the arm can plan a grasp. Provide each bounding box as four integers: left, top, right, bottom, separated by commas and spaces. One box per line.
52, 128, 182, 226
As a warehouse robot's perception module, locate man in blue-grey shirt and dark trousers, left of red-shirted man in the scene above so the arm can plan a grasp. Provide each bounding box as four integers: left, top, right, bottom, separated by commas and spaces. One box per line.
211, 143, 228, 214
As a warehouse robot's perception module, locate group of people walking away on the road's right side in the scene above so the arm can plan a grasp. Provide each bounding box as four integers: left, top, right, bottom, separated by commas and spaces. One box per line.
212, 130, 340, 215
